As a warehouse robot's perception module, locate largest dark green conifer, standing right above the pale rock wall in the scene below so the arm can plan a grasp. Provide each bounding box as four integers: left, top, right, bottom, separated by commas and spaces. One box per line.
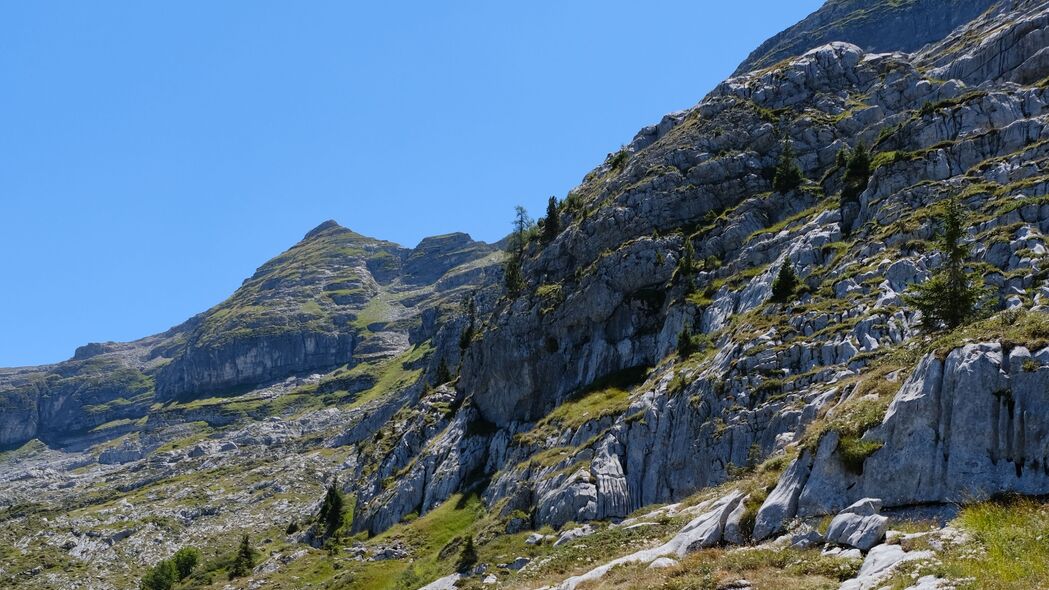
904, 198, 984, 330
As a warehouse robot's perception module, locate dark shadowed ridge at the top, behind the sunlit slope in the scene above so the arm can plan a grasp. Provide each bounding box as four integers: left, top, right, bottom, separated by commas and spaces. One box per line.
732, 0, 996, 76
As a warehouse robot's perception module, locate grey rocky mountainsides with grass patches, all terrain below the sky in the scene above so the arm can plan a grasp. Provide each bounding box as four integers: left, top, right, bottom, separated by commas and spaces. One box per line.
6, 0, 1049, 590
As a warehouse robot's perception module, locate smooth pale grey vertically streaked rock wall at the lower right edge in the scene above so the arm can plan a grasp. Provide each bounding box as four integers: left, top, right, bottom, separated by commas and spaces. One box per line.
790, 342, 1049, 515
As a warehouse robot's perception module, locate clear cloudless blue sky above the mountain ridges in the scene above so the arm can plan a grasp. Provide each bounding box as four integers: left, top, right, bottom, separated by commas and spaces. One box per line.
0, 0, 820, 366
